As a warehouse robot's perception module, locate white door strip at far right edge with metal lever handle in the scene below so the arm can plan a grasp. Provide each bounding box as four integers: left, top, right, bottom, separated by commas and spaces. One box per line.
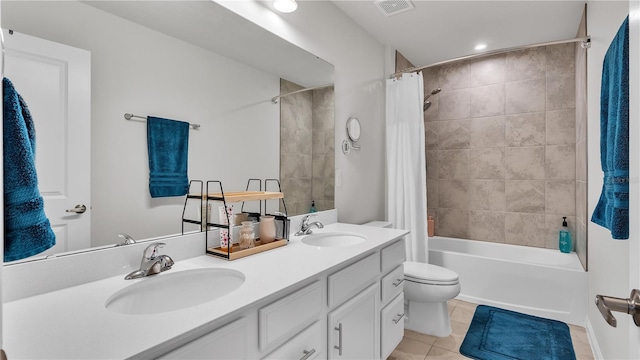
628, 1, 640, 359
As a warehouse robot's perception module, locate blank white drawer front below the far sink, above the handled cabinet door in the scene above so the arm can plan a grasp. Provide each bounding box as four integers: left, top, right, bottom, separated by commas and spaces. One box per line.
328, 253, 380, 307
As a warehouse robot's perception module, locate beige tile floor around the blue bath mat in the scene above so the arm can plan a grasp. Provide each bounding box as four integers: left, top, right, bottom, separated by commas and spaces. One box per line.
387, 300, 593, 360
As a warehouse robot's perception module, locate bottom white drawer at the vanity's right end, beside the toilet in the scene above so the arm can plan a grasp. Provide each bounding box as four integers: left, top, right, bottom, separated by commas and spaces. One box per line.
380, 294, 404, 359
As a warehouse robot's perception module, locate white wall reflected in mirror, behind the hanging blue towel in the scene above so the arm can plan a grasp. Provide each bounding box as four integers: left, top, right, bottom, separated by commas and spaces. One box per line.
2, 1, 280, 246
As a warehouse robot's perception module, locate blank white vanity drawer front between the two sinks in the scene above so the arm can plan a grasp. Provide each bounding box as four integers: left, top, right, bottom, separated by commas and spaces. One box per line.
258, 281, 323, 351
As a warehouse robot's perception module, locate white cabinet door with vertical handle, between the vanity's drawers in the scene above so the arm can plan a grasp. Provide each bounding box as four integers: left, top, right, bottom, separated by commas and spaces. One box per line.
328, 284, 379, 359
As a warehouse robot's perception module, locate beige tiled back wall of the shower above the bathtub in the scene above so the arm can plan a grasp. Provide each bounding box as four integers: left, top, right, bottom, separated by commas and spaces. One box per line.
424, 43, 576, 248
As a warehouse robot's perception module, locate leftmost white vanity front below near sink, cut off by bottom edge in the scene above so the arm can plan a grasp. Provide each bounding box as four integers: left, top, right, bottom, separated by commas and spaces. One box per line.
158, 318, 247, 360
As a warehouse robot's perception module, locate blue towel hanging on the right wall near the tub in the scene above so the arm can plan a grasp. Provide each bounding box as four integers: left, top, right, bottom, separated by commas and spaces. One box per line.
591, 16, 629, 239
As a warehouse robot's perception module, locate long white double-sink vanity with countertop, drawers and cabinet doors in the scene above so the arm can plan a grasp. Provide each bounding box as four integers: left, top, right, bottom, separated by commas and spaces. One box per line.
4, 219, 407, 359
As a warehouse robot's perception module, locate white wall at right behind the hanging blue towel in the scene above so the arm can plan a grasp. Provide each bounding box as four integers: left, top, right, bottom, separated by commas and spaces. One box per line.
587, 1, 631, 359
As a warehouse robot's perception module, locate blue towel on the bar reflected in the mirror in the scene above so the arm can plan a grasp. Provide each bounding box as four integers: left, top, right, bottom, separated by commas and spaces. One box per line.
147, 116, 189, 198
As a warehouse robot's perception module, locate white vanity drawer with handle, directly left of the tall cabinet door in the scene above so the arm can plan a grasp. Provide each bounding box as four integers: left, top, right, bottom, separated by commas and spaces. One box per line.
265, 321, 323, 360
